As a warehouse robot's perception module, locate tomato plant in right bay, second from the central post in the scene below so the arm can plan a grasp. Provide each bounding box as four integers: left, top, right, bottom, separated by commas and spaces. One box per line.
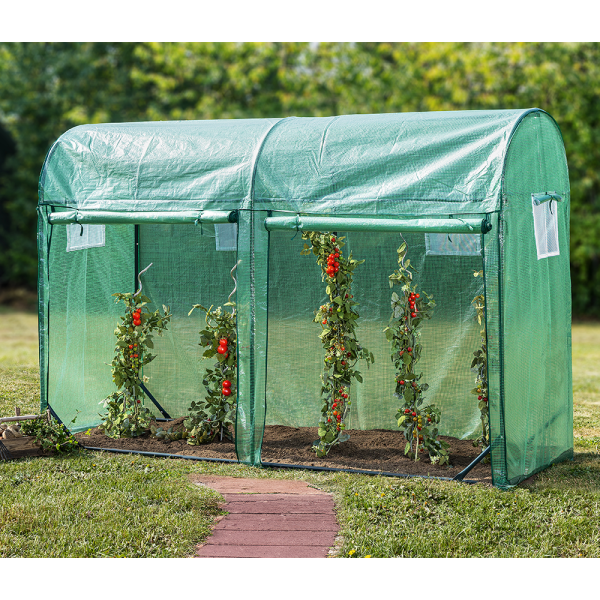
384, 244, 450, 465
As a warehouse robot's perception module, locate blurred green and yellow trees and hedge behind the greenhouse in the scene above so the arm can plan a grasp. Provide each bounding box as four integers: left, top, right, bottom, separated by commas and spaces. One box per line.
0, 42, 600, 317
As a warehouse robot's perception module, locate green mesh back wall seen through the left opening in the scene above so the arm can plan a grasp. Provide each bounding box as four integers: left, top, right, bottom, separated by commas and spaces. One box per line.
139, 225, 237, 419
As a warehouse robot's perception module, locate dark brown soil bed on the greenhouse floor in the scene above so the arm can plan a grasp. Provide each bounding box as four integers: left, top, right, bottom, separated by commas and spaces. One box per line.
76, 419, 492, 485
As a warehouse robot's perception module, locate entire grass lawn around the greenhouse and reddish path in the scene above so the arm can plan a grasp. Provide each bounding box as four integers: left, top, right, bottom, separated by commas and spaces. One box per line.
0, 308, 600, 558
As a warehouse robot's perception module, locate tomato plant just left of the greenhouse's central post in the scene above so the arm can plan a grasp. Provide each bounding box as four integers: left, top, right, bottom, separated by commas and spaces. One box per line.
185, 302, 237, 446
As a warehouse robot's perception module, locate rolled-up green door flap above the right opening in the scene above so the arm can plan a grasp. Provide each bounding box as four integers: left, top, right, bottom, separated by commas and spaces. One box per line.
265, 216, 492, 235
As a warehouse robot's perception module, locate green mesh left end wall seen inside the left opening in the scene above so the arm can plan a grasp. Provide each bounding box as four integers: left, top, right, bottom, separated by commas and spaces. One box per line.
42, 226, 135, 431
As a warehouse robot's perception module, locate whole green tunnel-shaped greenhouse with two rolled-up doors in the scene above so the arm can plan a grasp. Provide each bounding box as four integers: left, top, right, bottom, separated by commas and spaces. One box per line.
38, 109, 574, 489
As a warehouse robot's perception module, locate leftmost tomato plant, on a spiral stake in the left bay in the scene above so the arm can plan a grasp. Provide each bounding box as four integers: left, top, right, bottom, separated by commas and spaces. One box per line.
100, 294, 172, 439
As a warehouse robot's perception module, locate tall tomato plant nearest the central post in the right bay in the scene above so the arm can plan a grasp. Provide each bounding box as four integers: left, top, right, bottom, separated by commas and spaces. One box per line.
301, 232, 375, 458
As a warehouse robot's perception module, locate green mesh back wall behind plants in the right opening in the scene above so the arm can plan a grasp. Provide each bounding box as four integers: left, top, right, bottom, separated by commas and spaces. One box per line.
267, 232, 483, 439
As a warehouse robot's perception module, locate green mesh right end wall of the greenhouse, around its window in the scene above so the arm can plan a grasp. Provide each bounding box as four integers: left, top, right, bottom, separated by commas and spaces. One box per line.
501, 113, 573, 484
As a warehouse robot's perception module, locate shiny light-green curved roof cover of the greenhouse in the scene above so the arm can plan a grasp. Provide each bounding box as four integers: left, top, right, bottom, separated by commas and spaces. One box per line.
40, 109, 556, 215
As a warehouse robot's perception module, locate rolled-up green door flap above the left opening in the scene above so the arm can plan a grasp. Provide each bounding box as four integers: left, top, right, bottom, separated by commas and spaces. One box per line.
48, 210, 237, 225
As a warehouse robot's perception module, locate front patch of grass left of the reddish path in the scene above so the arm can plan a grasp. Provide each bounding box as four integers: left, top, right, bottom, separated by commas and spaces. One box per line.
0, 453, 227, 558
